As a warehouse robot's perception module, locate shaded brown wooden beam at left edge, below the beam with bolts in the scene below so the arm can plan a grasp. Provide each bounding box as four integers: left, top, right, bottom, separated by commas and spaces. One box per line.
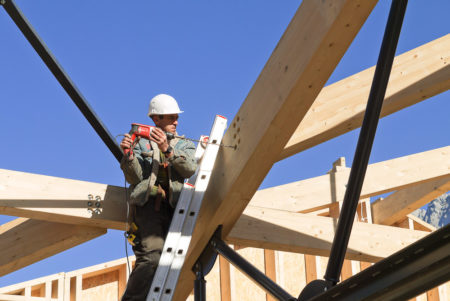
0, 218, 106, 276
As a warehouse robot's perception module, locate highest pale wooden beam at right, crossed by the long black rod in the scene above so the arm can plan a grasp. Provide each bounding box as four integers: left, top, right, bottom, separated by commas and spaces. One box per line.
278, 34, 450, 160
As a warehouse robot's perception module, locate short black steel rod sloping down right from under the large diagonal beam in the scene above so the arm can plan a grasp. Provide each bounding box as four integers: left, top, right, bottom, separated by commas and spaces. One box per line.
210, 236, 297, 301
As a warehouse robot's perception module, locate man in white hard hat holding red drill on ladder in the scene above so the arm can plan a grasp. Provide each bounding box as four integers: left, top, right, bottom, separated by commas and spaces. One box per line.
120, 94, 197, 301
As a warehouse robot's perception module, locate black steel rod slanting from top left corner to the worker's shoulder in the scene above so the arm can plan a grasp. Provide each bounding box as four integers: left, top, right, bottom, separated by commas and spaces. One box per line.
0, 0, 123, 162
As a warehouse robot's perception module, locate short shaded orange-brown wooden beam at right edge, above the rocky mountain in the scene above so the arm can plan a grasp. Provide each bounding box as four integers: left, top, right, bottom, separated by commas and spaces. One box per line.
371, 176, 450, 225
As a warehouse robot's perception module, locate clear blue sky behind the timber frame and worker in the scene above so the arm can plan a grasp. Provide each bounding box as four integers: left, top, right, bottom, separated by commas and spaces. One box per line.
0, 0, 450, 287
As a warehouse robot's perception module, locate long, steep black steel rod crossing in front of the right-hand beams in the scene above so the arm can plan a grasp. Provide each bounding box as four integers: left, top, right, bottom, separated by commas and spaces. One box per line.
325, 0, 408, 285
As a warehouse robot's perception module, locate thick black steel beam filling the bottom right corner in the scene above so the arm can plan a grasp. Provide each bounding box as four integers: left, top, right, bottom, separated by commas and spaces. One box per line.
309, 225, 450, 301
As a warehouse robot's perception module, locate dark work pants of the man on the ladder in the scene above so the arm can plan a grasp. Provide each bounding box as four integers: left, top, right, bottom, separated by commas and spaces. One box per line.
122, 199, 173, 301
